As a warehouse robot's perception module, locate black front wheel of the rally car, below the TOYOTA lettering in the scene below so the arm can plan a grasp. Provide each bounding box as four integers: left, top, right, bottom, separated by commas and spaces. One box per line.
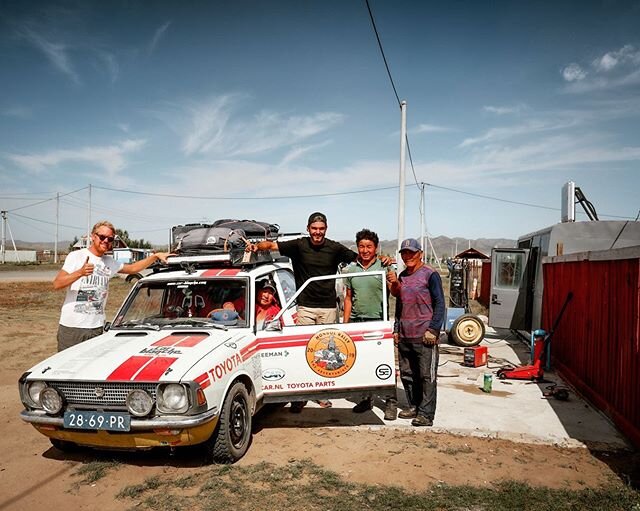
211, 382, 251, 463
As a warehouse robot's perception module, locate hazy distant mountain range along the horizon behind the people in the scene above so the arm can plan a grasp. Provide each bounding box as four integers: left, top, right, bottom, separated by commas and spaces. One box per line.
12, 236, 516, 258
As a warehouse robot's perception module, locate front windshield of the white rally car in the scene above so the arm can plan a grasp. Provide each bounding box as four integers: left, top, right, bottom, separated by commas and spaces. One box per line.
112, 278, 248, 330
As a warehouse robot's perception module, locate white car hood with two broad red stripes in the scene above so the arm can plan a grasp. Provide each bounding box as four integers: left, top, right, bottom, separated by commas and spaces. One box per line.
29, 329, 246, 382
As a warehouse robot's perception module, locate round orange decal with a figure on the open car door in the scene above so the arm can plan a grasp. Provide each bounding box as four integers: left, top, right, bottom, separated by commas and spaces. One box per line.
306, 328, 356, 378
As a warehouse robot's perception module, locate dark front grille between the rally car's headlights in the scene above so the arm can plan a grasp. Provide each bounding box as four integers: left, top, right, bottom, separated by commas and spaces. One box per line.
49, 382, 156, 408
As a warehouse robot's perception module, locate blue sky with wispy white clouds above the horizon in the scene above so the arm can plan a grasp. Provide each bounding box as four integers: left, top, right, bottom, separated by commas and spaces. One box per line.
0, 0, 640, 248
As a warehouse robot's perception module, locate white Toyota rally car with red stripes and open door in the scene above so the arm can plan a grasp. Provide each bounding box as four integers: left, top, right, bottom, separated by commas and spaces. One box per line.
19, 254, 396, 463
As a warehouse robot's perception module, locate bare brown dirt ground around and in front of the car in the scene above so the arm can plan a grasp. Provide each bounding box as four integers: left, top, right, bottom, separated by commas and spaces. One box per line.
0, 279, 638, 511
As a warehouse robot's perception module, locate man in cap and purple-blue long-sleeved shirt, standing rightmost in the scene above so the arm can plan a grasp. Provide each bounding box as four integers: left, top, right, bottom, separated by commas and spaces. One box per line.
387, 238, 445, 426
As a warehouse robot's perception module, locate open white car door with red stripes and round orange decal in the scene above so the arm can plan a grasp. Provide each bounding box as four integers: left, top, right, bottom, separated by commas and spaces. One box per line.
257, 271, 396, 402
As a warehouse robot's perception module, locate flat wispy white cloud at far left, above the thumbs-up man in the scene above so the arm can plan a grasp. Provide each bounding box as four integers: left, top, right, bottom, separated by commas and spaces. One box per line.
6, 140, 145, 178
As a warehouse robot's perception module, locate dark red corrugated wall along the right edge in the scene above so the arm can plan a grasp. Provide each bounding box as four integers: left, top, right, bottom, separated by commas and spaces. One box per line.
542, 258, 640, 447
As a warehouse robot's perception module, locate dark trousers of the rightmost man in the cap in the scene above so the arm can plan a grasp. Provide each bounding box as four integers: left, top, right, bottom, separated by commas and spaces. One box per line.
398, 339, 440, 420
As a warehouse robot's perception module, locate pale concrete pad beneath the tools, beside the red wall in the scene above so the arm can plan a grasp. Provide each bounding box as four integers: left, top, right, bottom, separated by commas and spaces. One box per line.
257, 328, 630, 449
